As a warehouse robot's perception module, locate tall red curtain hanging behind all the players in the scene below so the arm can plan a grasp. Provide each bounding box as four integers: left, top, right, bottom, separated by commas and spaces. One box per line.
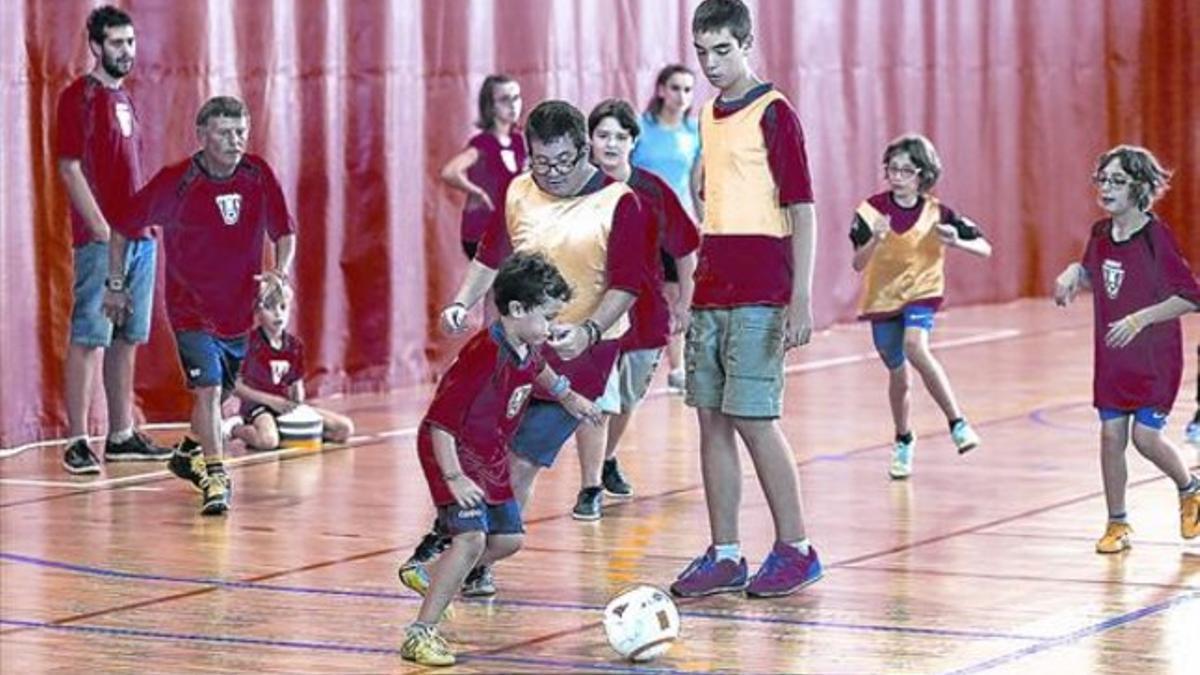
0, 0, 1200, 446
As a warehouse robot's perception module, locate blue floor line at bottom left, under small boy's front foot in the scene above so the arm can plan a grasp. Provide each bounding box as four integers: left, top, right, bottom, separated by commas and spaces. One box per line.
0, 619, 697, 675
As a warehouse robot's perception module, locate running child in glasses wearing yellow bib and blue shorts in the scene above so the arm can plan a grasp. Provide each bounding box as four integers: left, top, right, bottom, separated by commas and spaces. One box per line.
850, 135, 991, 479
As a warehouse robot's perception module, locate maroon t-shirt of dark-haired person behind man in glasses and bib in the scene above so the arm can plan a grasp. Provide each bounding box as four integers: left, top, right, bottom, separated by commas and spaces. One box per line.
620, 167, 700, 352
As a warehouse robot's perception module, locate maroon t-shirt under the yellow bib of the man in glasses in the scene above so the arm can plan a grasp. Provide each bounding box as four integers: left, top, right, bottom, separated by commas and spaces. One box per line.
475, 171, 659, 400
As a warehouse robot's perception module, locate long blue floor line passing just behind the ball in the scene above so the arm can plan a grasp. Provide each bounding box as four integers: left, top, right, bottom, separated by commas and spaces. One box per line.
0, 552, 1046, 641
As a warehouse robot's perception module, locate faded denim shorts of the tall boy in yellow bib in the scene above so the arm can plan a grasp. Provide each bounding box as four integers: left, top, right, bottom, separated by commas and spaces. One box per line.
685, 305, 786, 418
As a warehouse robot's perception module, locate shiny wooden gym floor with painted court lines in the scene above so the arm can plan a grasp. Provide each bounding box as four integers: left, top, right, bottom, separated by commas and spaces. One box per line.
0, 298, 1200, 675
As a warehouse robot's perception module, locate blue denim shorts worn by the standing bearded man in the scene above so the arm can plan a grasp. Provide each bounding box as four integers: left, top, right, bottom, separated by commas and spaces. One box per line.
71, 239, 157, 347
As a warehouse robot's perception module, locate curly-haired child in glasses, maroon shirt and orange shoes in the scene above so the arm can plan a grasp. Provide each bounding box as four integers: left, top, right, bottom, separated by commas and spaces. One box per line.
1055, 145, 1200, 554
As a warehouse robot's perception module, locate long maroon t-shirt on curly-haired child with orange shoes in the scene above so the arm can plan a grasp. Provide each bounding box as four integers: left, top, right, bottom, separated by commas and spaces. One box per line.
1082, 214, 1200, 413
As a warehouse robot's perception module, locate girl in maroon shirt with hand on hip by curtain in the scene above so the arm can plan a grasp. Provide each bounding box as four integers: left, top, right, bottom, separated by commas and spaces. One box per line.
442, 74, 526, 259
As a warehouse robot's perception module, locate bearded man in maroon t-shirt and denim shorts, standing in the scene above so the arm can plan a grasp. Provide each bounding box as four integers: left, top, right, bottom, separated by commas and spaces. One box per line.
58, 6, 170, 474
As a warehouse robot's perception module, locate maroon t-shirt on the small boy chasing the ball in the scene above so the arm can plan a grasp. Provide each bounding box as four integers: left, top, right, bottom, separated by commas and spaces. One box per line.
416, 323, 545, 506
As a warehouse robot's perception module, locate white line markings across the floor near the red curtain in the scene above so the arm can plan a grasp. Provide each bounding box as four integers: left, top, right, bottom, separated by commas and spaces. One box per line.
0, 328, 1022, 482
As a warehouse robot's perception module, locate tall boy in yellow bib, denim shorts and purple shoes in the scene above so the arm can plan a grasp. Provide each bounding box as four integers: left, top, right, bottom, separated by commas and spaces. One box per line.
671, 0, 822, 597
